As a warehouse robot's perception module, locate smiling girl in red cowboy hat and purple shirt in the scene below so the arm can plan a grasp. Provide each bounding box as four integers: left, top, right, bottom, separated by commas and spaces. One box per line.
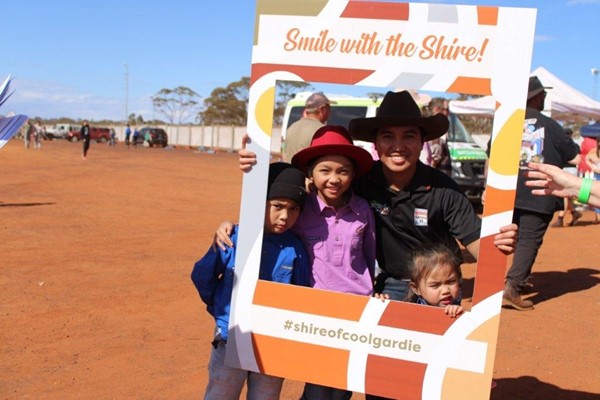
292, 125, 375, 400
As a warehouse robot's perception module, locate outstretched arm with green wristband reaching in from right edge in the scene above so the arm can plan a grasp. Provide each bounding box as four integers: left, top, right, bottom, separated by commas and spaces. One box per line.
525, 163, 600, 208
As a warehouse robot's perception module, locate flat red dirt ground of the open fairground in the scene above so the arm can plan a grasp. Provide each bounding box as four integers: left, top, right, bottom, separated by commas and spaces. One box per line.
0, 140, 600, 400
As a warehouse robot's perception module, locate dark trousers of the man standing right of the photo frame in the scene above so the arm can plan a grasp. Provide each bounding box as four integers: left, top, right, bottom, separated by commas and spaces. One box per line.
506, 208, 552, 292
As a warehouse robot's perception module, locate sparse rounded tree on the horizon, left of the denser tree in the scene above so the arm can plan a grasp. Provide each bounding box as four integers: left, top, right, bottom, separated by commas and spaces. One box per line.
152, 86, 200, 125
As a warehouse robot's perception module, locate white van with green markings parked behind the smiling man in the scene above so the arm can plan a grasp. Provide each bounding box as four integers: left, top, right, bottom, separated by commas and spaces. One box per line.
281, 92, 487, 205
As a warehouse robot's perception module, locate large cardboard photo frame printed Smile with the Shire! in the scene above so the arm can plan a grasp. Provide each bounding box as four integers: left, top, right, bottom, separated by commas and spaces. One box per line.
226, 0, 536, 399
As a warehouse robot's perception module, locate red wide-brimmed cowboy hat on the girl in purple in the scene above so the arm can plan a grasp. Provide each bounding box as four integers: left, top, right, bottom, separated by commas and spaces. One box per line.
292, 125, 373, 177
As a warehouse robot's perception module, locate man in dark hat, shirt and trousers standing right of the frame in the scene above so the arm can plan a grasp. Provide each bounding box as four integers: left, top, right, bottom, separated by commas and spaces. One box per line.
504, 76, 581, 311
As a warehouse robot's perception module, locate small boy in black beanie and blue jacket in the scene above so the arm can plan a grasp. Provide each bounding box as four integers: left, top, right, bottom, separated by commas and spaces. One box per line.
191, 162, 310, 400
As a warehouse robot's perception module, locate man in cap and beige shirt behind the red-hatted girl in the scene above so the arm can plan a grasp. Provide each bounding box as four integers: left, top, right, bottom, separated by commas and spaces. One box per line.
283, 92, 335, 162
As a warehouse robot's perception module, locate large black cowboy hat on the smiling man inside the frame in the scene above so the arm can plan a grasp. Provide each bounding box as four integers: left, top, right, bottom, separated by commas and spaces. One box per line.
348, 90, 449, 142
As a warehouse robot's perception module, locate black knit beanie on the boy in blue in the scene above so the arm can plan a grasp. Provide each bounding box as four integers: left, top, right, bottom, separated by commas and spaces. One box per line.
267, 162, 306, 207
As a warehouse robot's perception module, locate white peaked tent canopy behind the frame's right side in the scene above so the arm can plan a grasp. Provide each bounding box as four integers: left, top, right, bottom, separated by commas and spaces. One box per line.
449, 67, 600, 119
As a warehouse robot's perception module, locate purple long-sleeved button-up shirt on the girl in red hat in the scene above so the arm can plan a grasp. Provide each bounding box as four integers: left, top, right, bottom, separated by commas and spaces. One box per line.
293, 193, 375, 295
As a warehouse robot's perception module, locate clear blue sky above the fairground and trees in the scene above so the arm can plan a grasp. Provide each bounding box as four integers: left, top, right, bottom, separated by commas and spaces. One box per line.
0, 0, 600, 120
